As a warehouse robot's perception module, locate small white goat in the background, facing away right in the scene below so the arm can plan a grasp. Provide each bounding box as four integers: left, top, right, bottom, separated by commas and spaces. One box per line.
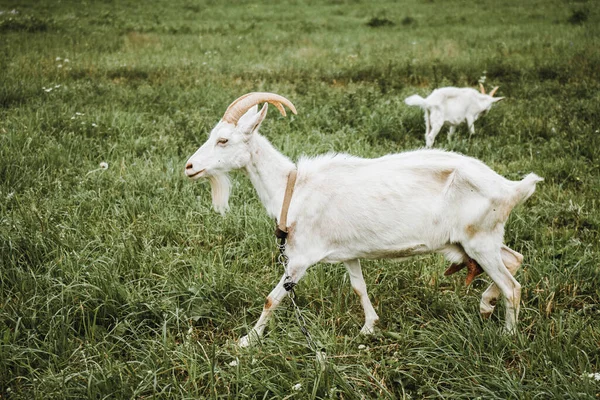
404, 84, 504, 147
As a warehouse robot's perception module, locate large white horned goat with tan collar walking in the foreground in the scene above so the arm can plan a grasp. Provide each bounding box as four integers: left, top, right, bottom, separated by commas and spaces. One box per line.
185, 93, 542, 346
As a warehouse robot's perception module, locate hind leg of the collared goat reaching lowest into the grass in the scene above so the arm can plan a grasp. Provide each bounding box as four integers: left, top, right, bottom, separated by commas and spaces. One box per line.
463, 237, 521, 333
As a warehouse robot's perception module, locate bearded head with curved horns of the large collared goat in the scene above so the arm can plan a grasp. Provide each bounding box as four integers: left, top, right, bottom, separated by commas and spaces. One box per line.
185, 93, 296, 214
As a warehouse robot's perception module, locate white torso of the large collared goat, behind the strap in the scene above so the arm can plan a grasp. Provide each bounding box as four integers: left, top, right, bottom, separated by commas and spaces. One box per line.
289, 150, 536, 260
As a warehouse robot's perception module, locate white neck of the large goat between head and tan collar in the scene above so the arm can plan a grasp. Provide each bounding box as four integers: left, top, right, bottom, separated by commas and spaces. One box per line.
245, 133, 295, 218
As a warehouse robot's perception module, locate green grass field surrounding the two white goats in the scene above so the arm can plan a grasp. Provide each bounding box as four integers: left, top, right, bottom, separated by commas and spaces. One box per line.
0, 0, 600, 399
